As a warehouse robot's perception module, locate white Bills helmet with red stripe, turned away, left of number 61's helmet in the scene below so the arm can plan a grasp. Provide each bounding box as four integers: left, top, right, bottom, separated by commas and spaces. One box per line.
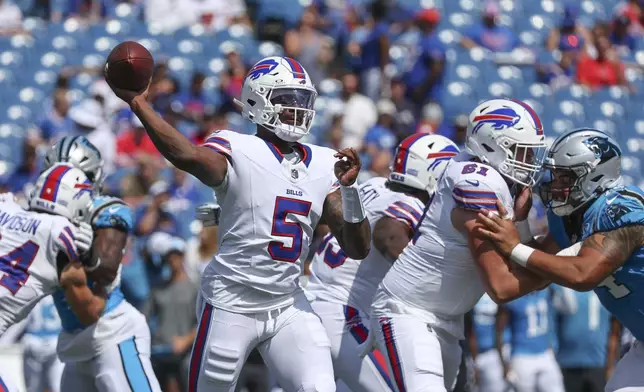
389, 133, 459, 194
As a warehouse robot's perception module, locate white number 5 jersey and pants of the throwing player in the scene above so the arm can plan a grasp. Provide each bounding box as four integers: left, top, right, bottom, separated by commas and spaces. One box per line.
189, 131, 337, 392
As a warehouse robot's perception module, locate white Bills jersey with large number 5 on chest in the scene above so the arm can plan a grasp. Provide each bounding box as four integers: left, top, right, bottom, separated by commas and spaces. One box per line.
201, 131, 337, 313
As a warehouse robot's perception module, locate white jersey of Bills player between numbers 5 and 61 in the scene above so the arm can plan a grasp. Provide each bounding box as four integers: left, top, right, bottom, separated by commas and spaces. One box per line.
306, 177, 425, 315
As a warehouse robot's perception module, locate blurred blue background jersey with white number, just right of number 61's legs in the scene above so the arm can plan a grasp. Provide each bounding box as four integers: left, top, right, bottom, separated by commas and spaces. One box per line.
505, 290, 552, 356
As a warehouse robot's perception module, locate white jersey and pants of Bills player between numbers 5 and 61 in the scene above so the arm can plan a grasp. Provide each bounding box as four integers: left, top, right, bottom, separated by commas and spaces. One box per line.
306, 178, 424, 392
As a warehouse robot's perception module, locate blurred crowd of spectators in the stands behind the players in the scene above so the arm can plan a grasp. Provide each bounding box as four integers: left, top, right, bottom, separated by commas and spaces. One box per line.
0, 0, 644, 392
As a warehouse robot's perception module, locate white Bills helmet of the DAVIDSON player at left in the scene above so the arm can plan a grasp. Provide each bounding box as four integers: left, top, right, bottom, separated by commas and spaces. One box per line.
29, 163, 94, 223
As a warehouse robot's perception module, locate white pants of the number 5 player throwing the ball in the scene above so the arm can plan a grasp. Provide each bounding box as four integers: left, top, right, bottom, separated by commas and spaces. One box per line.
188, 294, 335, 392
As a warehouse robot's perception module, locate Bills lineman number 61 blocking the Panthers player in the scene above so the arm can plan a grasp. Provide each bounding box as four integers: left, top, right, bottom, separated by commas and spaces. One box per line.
371, 99, 546, 392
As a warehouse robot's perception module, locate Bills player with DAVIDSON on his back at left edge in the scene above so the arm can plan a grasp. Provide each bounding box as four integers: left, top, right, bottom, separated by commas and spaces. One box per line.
0, 165, 98, 335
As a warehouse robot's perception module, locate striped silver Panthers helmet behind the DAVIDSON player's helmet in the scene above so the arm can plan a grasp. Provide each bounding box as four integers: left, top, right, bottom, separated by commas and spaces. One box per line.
43, 136, 103, 189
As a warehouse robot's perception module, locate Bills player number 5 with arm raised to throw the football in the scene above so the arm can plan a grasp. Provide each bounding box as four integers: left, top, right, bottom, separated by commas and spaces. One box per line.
112, 57, 371, 392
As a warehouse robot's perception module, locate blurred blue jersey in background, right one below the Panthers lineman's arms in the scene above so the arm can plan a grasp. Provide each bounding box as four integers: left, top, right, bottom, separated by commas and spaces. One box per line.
551, 285, 611, 368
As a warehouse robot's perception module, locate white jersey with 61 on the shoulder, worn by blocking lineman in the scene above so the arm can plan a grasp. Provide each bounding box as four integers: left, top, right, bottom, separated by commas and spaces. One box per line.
372, 153, 513, 339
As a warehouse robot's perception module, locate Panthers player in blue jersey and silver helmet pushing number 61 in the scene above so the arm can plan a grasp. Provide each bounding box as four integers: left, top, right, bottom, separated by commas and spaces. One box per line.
478, 128, 644, 392
